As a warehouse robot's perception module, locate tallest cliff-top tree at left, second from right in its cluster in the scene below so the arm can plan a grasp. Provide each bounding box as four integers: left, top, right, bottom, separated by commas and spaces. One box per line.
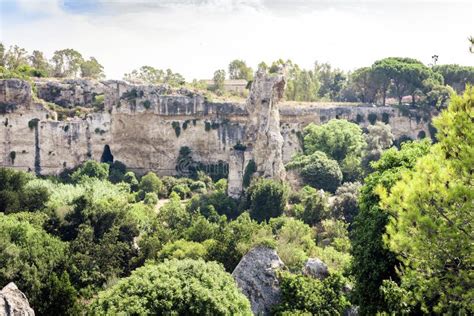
52, 48, 84, 78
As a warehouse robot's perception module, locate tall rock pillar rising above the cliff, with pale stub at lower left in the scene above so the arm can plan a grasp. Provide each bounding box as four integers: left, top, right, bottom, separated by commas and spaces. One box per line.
229, 70, 286, 197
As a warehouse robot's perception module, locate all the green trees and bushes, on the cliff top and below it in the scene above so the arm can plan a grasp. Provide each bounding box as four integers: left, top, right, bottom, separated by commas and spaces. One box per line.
0, 41, 474, 315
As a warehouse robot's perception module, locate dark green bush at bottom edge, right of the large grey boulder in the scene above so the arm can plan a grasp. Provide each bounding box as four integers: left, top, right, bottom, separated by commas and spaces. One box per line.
275, 272, 350, 315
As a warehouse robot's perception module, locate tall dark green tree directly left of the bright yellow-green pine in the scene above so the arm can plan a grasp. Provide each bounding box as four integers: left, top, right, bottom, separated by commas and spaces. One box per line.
351, 141, 430, 315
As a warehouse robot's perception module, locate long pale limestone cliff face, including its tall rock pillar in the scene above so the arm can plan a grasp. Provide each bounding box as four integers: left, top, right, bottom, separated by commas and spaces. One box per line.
0, 78, 429, 195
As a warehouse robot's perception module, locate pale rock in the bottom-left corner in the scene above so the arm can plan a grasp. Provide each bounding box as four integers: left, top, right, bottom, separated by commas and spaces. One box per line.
0, 282, 35, 316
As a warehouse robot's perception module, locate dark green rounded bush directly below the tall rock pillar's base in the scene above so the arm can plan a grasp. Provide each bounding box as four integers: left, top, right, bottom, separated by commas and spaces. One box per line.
246, 178, 289, 222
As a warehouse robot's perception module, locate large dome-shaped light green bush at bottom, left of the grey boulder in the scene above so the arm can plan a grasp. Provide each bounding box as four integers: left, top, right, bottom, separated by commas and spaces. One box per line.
89, 259, 252, 315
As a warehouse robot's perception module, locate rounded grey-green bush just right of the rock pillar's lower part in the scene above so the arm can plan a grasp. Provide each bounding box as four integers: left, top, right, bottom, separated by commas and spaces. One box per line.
286, 151, 342, 192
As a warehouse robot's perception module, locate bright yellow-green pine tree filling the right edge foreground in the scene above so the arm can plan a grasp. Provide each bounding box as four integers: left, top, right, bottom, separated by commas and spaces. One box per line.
381, 87, 474, 314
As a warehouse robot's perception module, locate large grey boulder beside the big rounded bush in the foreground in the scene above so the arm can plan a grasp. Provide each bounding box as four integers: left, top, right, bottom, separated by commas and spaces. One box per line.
232, 246, 285, 315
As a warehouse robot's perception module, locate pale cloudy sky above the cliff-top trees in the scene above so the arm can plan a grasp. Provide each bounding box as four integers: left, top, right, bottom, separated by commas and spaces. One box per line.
0, 0, 474, 80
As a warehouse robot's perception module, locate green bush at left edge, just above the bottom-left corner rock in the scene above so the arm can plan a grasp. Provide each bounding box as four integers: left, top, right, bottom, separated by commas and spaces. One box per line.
0, 214, 75, 314
